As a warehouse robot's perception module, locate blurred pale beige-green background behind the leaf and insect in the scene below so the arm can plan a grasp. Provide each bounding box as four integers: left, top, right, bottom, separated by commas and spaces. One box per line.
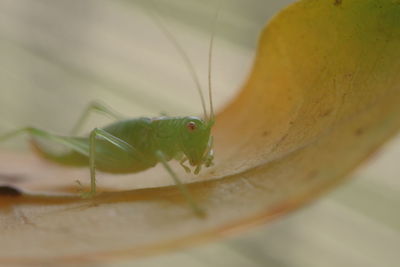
0, 0, 400, 267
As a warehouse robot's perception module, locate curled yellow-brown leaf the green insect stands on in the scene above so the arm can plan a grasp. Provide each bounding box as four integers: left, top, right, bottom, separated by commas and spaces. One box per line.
0, 0, 400, 262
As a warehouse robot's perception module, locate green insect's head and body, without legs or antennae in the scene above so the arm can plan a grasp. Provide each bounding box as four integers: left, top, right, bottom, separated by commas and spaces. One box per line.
32, 117, 212, 173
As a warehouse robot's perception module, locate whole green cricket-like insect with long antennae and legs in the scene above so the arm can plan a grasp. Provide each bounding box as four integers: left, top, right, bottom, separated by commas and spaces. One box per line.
0, 4, 218, 216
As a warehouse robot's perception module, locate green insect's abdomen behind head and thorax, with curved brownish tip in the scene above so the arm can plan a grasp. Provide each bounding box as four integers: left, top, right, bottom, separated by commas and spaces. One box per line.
31, 118, 157, 173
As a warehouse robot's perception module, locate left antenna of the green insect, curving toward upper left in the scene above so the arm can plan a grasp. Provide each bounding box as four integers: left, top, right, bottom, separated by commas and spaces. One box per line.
146, 1, 208, 119
